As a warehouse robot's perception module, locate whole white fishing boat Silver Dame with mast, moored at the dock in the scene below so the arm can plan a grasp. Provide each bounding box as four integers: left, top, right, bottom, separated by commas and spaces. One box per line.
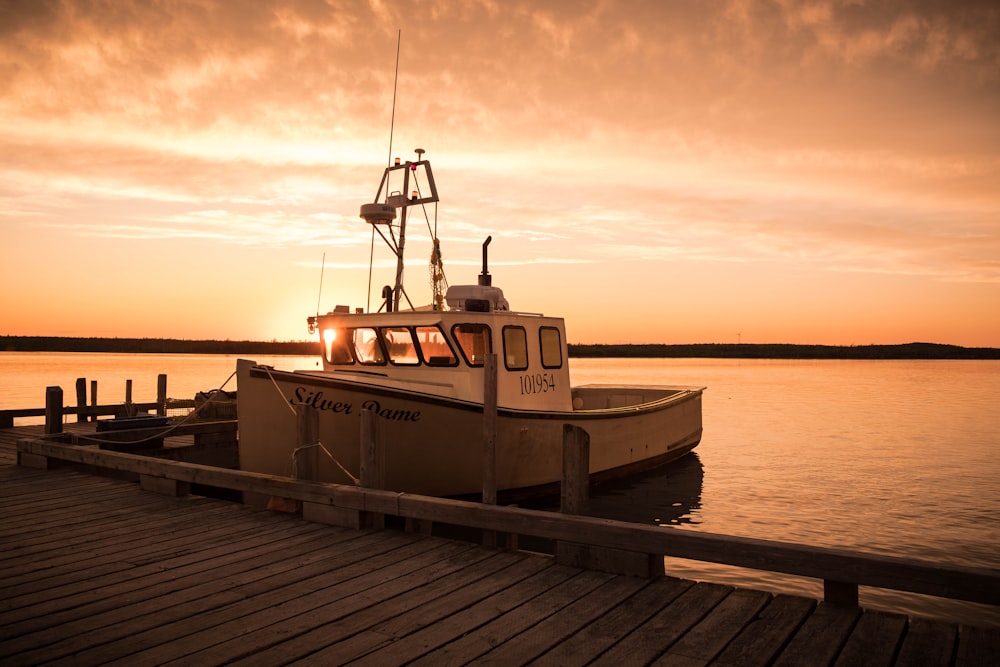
237, 149, 703, 496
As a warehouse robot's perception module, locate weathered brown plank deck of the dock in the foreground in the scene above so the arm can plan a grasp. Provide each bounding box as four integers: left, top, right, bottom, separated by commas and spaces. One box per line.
0, 425, 1000, 666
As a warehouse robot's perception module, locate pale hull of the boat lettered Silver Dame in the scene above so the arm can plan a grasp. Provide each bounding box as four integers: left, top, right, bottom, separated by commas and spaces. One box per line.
238, 362, 702, 497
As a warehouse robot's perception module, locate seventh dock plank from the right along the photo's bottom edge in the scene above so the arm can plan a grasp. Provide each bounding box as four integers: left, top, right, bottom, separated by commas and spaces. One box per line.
591, 583, 733, 667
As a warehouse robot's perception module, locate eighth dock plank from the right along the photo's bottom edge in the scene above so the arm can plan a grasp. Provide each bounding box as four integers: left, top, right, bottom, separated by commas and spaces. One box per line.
530, 577, 694, 665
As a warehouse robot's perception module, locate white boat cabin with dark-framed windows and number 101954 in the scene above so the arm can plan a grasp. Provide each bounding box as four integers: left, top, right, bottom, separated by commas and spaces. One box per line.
309, 285, 572, 411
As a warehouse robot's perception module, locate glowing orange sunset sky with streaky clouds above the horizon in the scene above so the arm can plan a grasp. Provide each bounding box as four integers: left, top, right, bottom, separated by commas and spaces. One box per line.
0, 0, 1000, 347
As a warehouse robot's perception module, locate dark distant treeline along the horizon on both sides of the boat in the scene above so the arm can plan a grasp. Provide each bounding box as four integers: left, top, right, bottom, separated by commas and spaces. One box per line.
0, 336, 1000, 359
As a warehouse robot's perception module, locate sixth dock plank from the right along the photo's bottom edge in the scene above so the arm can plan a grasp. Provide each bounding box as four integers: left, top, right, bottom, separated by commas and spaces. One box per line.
653, 589, 771, 666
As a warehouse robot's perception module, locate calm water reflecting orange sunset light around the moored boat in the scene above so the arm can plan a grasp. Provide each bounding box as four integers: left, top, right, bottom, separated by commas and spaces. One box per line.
0, 353, 1000, 626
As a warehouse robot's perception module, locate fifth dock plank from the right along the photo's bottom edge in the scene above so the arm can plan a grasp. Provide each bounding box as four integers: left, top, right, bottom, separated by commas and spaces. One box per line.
715, 595, 816, 667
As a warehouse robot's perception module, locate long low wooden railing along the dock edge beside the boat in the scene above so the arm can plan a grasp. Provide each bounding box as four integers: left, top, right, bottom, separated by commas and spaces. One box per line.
17, 427, 1000, 616
